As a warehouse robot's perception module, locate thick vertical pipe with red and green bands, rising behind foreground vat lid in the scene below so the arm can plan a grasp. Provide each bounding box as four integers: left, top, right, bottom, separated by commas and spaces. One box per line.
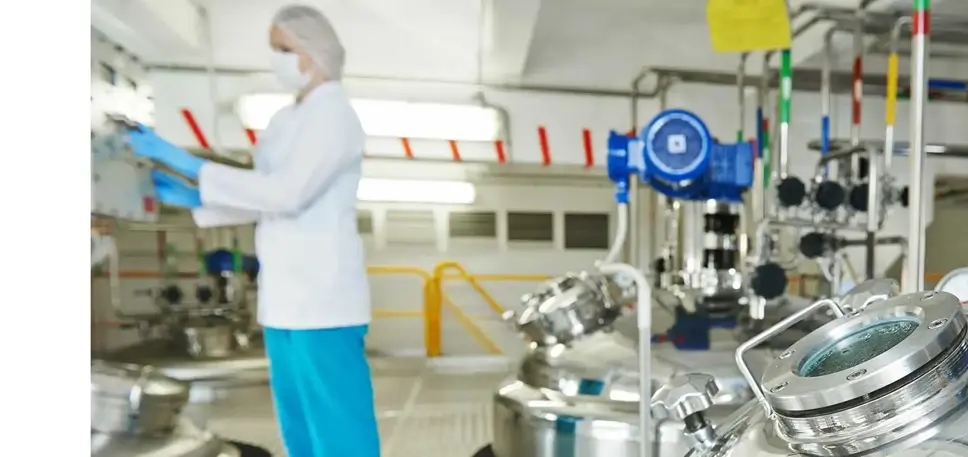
902, 0, 931, 292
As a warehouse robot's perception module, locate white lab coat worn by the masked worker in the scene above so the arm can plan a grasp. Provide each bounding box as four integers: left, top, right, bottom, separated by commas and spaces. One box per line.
193, 82, 370, 329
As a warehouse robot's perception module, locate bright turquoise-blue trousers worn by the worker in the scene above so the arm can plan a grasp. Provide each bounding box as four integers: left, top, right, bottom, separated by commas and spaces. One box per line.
265, 325, 380, 457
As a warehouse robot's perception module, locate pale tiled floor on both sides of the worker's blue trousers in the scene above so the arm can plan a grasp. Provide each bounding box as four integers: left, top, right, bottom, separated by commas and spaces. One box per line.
188, 358, 508, 457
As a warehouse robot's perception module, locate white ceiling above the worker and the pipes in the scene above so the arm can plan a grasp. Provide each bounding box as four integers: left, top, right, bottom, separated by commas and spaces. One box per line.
104, 0, 968, 88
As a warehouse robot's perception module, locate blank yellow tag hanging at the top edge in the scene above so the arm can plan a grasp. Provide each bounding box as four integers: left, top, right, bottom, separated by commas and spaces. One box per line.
706, 0, 790, 52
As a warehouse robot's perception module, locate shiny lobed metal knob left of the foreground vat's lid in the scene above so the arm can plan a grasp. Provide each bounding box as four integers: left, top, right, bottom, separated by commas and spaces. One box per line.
651, 373, 719, 421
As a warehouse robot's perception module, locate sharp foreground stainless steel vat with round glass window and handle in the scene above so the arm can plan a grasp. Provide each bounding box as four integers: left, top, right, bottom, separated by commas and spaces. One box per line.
652, 280, 968, 457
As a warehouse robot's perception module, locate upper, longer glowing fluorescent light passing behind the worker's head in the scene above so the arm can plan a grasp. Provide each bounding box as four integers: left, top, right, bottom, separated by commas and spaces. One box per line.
236, 94, 501, 141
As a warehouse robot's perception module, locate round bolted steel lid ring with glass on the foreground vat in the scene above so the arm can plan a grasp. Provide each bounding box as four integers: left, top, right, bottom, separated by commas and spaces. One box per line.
761, 292, 966, 412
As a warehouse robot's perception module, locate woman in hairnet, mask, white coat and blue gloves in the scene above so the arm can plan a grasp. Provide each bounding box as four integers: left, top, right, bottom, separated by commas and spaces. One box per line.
130, 6, 380, 457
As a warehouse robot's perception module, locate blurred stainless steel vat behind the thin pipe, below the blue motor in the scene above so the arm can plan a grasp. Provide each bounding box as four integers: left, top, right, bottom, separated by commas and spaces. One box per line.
491, 315, 774, 457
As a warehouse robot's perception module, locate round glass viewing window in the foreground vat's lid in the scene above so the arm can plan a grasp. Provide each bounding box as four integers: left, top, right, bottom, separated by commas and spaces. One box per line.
797, 317, 920, 378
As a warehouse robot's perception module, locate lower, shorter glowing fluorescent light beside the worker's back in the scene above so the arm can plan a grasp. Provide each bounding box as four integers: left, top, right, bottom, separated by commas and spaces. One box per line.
356, 178, 477, 205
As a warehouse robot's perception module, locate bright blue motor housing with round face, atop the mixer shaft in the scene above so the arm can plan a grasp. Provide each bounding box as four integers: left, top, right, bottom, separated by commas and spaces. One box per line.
607, 110, 754, 202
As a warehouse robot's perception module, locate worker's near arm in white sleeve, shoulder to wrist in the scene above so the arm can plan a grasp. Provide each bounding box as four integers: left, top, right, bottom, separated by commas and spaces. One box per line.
199, 104, 364, 214
